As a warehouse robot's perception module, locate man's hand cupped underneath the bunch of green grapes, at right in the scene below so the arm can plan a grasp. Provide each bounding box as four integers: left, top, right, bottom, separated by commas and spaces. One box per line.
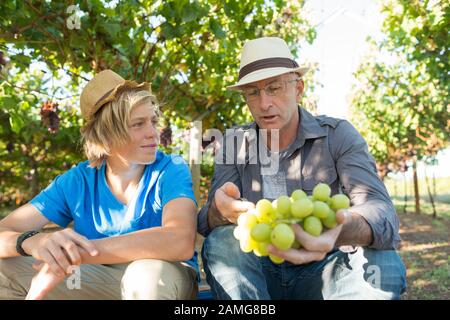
268, 210, 352, 264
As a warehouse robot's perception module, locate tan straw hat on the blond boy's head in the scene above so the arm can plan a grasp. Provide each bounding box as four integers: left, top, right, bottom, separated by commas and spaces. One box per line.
80, 70, 152, 120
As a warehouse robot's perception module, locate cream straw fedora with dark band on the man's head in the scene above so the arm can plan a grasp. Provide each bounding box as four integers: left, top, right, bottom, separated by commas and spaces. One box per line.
227, 37, 309, 90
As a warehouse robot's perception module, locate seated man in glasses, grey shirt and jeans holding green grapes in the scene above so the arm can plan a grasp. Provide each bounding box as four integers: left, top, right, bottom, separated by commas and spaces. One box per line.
198, 37, 406, 299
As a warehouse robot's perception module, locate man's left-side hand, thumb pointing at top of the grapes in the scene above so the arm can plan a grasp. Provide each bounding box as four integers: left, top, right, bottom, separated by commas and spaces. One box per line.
214, 182, 255, 223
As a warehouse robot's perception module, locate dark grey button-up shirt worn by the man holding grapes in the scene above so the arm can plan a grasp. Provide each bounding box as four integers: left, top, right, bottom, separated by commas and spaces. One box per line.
198, 108, 400, 250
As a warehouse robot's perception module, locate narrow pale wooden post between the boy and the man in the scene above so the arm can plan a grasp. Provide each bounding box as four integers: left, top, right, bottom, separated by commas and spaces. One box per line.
189, 121, 202, 203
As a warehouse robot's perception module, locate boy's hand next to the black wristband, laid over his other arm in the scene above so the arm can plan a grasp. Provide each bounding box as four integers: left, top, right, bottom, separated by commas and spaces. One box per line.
22, 228, 98, 277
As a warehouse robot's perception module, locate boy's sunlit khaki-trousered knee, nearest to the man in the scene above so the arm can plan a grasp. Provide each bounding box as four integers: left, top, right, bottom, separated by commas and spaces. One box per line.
121, 259, 196, 300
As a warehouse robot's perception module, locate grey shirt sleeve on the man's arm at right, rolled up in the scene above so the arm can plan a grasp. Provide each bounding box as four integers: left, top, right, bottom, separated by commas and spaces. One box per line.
330, 121, 400, 250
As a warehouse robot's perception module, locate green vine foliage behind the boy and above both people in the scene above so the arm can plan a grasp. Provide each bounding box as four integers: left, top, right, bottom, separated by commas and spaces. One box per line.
0, 0, 315, 199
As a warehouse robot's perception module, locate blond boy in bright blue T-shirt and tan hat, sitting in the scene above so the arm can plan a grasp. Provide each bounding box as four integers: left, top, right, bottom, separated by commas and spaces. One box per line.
0, 70, 197, 299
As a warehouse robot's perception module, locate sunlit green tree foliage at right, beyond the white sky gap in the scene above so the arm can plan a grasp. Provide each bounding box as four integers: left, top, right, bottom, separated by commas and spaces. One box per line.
352, 0, 450, 176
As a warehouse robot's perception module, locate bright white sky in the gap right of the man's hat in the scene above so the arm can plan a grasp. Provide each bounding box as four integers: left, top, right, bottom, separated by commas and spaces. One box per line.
299, 0, 450, 177
